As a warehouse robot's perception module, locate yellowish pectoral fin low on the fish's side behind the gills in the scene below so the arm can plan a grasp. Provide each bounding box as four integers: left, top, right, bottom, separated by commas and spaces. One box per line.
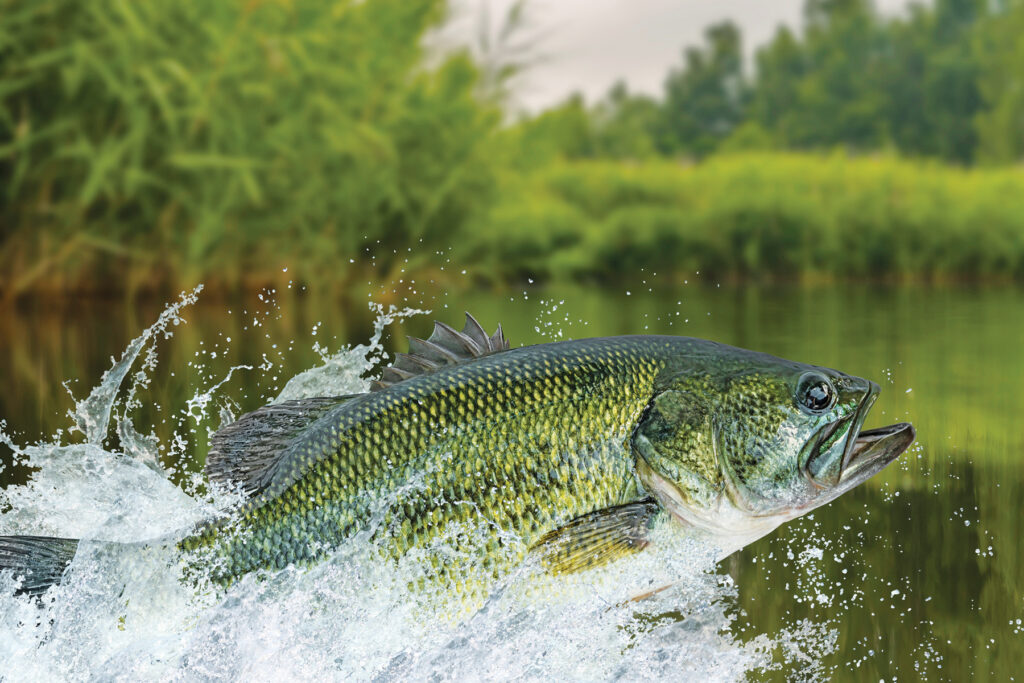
532, 498, 660, 573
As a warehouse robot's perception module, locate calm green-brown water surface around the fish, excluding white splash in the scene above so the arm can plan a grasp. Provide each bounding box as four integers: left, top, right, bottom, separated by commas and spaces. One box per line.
0, 284, 1024, 681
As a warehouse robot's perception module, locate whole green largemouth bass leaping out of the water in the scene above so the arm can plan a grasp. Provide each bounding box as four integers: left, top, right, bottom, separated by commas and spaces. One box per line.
0, 313, 915, 596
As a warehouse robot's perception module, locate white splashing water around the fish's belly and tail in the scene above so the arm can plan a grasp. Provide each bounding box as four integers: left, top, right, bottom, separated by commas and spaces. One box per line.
0, 289, 836, 681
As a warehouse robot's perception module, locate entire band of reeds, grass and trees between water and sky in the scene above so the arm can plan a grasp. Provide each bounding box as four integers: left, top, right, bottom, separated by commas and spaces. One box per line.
0, 0, 1024, 297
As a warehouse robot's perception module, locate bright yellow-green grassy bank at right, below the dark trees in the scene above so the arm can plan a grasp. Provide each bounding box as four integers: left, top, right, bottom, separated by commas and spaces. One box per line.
458, 153, 1024, 280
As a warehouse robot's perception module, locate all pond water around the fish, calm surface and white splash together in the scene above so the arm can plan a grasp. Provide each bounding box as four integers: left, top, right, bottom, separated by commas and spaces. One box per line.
0, 283, 1024, 681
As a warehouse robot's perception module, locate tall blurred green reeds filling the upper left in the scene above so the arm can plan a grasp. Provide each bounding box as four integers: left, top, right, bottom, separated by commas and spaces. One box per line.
0, 0, 500, 291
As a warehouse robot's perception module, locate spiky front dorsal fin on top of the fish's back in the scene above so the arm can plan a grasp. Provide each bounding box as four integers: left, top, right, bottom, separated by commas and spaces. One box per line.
370, 313, 509, 391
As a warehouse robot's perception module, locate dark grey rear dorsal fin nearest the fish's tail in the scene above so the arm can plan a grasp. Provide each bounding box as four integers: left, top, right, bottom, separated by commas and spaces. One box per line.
206, 394, 361, 496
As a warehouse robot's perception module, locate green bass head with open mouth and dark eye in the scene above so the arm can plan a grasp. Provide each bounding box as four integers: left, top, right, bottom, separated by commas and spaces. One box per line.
632, 349, 914, 552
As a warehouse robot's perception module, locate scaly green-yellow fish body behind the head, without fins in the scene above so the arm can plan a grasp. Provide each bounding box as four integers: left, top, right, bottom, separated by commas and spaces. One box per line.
181, 338, 667, 583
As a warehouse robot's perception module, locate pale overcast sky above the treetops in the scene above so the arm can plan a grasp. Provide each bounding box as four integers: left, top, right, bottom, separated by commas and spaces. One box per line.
455, 0, 921, 110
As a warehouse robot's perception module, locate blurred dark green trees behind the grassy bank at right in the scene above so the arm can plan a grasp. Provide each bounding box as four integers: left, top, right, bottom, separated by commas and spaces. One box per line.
520, 0, 1024, 165
